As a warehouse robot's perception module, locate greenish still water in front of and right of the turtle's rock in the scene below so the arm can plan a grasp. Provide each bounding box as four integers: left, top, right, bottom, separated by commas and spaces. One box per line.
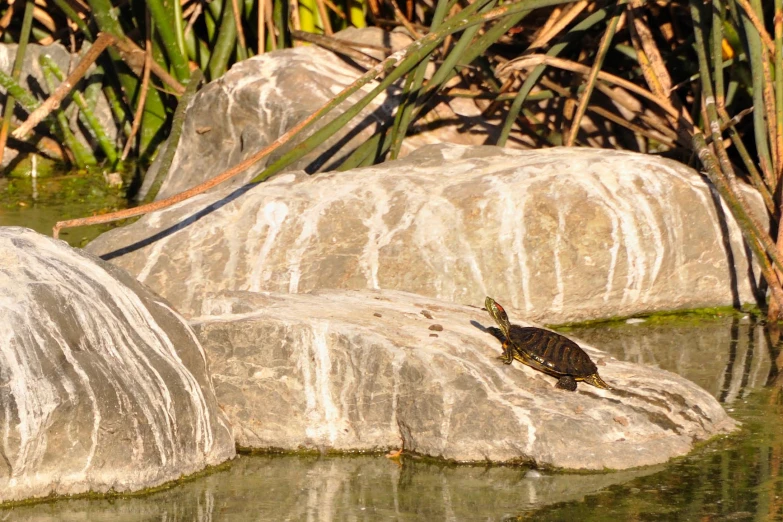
0, 315, 783, 522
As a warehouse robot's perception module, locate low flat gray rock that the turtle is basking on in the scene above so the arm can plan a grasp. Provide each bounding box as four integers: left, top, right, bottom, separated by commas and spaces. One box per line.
191, 291, 735, 470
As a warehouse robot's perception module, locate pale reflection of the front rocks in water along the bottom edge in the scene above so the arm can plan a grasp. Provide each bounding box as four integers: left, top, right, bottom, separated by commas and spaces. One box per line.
0, 456, 661, 522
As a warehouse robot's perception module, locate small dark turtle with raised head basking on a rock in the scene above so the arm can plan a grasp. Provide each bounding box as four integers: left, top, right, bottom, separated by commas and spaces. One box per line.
484, 297, 610, 391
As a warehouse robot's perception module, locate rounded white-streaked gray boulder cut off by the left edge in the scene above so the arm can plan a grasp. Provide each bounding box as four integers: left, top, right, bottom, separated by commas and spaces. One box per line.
0, 227, 235, 503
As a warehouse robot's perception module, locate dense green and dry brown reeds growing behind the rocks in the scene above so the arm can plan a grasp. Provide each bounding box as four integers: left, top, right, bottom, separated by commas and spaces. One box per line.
0, 0, 783, 321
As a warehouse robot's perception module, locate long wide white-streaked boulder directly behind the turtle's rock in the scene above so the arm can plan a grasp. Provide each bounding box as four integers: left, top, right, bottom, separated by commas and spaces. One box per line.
87, 145, 763, 324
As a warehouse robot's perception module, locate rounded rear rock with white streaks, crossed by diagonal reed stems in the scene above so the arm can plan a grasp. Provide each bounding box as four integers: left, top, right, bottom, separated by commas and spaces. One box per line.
139, 38, 399, 199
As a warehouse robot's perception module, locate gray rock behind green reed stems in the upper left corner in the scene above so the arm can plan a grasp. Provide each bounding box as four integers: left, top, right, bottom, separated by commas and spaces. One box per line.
0, 43, 117, 167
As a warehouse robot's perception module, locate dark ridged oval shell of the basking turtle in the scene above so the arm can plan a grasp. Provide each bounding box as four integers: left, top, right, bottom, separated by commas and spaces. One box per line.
509, 324, 598, 378
